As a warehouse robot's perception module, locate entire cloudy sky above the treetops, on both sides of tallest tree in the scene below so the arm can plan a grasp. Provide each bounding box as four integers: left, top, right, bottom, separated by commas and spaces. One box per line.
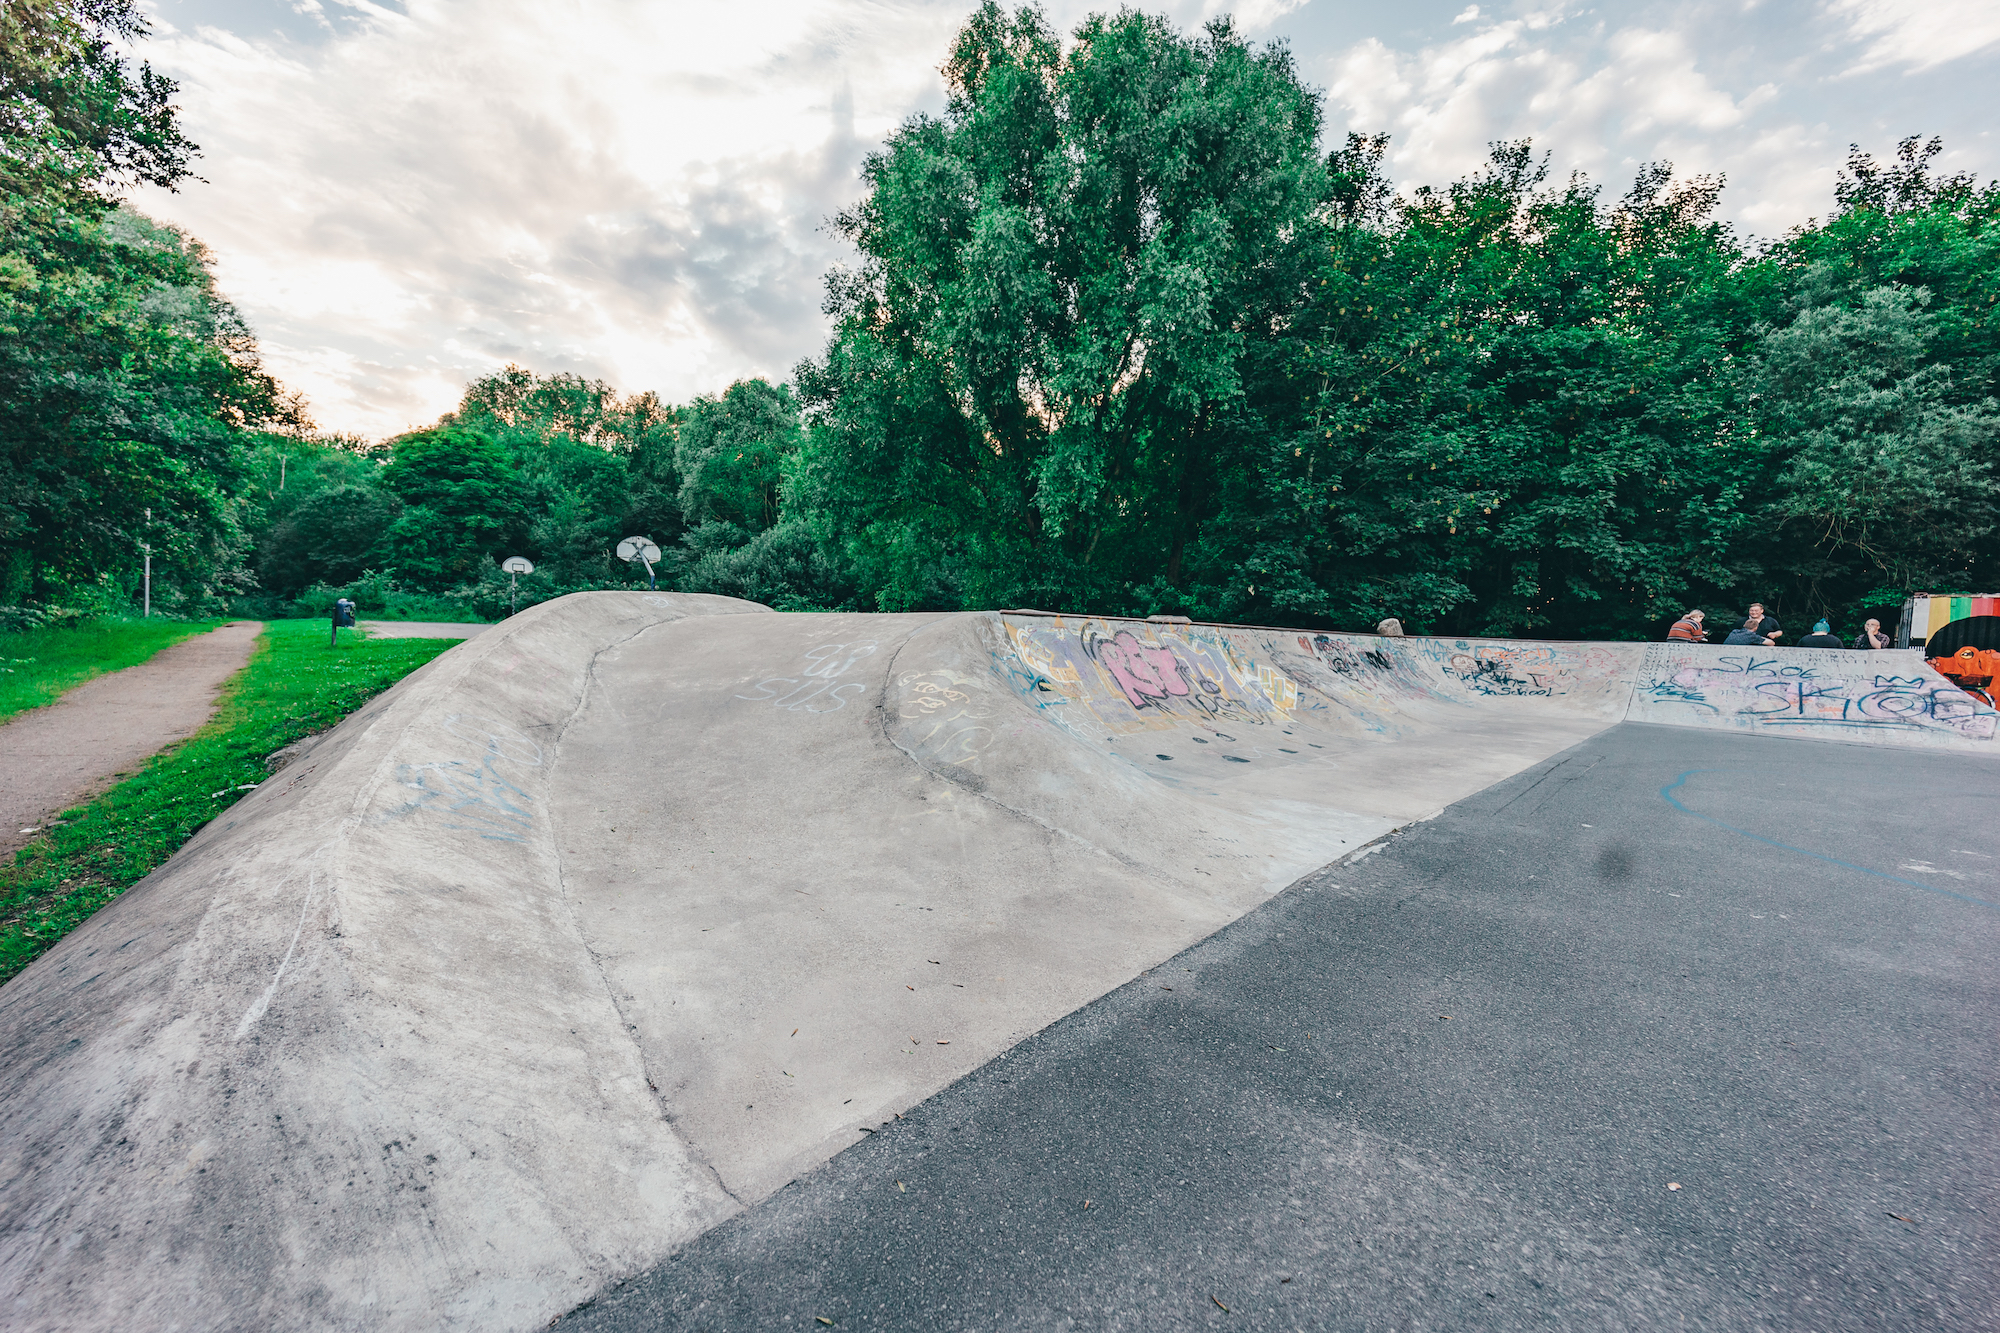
134, 0, 2000, 438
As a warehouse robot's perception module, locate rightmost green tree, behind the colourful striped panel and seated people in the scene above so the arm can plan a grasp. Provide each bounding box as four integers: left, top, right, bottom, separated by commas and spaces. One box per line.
1740, 136, 2000, 614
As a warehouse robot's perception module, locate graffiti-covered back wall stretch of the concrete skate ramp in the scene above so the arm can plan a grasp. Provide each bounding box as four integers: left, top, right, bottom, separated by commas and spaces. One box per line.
990, 616, 2000, 745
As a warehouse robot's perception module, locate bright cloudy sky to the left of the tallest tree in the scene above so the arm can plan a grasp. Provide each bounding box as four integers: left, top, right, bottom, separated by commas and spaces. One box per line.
140, 0, 958, 434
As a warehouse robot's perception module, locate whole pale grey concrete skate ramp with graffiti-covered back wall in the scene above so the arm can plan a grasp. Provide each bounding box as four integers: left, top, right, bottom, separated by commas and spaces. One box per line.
0, 592, 1996, 1329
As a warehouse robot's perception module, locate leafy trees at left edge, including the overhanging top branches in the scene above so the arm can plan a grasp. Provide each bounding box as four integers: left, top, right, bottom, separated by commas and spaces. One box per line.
0, 0, 306, 608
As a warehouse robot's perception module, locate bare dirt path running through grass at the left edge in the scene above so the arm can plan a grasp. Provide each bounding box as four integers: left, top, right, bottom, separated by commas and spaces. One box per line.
0, 620, 264, 853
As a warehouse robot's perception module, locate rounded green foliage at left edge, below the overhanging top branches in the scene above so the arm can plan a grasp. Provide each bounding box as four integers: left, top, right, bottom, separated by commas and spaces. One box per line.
0, 198, 302, 608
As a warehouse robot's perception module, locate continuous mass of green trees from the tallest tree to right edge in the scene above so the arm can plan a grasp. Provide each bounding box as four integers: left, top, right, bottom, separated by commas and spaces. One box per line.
776, 4, 2000, 638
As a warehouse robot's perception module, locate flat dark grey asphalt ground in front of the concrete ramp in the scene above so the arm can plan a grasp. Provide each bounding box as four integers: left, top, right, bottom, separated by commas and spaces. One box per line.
554, 723, 2000, 1333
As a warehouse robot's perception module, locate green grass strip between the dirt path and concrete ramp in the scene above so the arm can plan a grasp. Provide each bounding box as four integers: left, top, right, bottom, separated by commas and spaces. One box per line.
0, 620, 458, 981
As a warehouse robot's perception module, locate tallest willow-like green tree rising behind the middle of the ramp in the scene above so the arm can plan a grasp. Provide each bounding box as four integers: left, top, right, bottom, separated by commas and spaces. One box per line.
792, 2, 1326, 608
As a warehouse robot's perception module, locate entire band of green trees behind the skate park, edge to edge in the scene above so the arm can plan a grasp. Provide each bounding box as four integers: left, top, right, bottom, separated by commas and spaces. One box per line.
0, 0, 2000, 638
